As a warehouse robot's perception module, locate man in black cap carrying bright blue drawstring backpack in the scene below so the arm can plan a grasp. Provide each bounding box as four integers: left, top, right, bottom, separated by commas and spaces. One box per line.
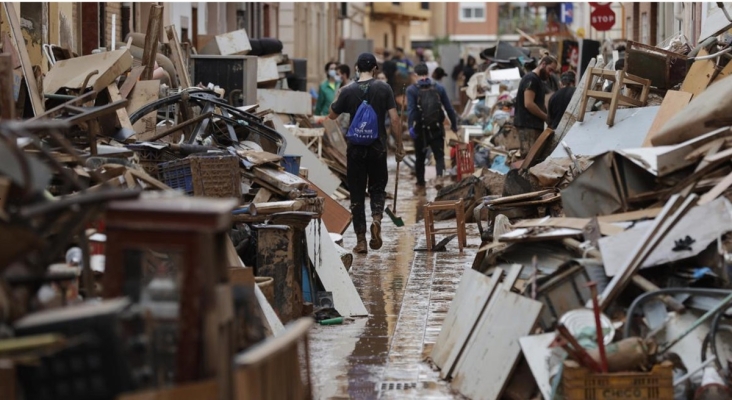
328, 53, 404, 254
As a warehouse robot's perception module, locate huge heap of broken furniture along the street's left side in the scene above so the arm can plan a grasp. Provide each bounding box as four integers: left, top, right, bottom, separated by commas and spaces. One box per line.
0, 3, 367, 400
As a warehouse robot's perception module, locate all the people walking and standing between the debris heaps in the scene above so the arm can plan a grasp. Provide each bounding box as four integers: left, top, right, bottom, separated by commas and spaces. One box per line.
315, 49, 575, 254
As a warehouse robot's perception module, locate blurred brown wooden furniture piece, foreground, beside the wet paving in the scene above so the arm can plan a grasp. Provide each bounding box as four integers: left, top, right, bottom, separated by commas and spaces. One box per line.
235, 318, 313, 400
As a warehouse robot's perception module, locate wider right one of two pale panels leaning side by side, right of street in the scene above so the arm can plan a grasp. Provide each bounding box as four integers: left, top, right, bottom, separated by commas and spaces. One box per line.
451, 290, 543, 400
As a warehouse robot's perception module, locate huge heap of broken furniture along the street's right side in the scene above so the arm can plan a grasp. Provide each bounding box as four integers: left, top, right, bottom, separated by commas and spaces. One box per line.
431, 35, 732, 400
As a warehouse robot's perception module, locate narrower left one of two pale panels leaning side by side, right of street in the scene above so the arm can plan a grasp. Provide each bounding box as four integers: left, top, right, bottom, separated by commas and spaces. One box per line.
430, 268, 503, 379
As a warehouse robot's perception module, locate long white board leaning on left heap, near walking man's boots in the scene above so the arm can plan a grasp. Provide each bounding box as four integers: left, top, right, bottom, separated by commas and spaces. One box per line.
305, 219, 368, 316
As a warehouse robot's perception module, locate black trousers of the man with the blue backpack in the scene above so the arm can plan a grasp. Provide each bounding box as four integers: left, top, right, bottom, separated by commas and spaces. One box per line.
347, 145, 389, 234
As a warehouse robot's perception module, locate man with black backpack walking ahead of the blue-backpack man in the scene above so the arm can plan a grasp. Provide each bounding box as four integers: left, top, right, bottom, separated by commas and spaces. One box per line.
407, 64, 457, 195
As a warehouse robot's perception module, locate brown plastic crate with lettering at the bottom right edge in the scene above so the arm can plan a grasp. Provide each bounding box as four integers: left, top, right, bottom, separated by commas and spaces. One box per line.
562, 361, 674, 400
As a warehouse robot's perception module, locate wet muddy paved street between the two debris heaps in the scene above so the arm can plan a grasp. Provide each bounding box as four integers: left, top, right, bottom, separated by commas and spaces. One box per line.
310, 158, 480, 399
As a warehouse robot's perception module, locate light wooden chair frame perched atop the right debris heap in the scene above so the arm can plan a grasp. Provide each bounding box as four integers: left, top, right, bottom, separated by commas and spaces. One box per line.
577, 68, 651, 126
